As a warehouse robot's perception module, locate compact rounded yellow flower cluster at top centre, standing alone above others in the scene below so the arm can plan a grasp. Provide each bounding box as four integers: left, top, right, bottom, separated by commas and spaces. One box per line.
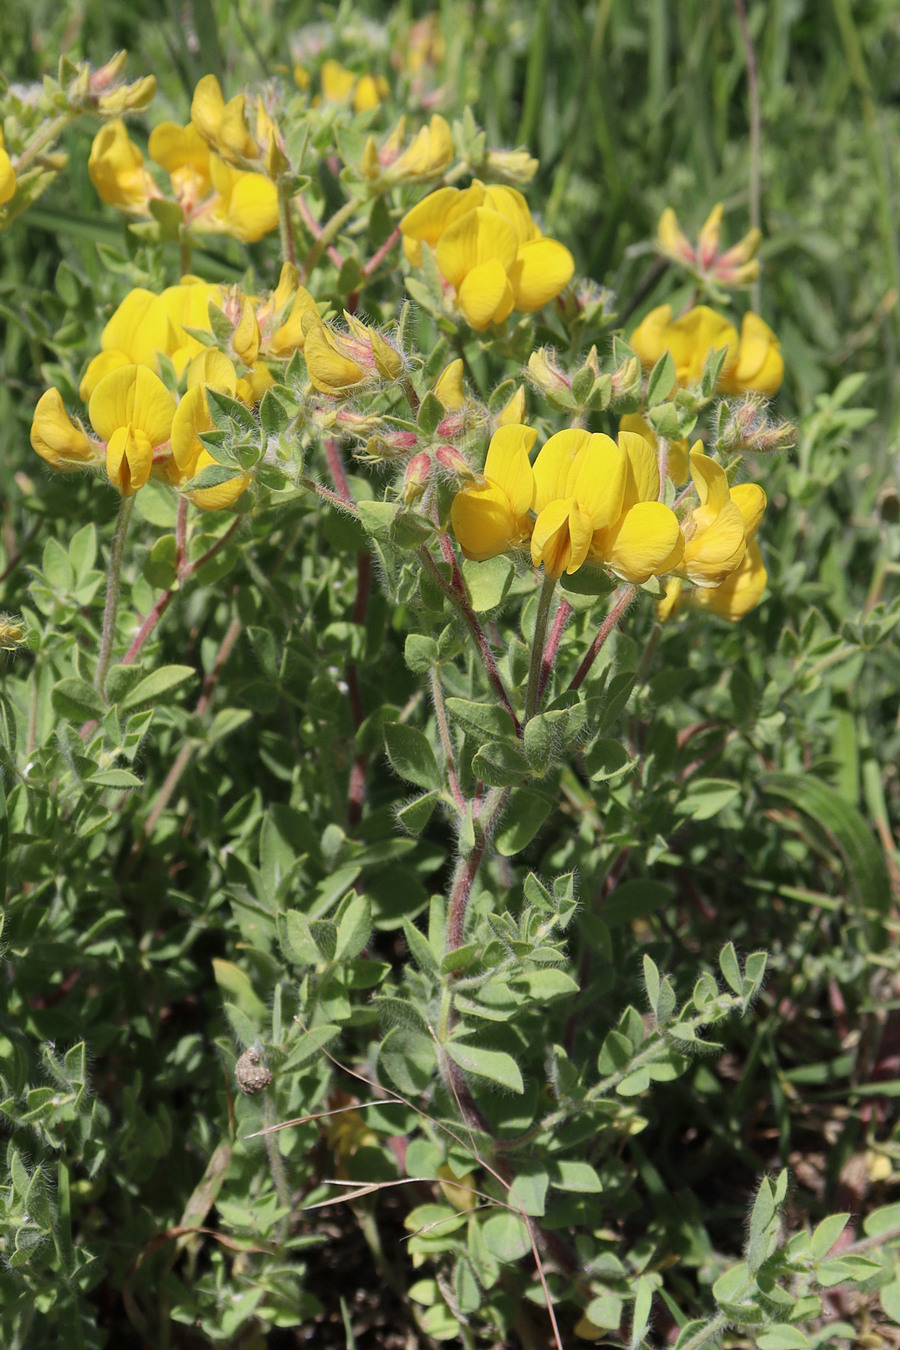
399, 180, 575, 332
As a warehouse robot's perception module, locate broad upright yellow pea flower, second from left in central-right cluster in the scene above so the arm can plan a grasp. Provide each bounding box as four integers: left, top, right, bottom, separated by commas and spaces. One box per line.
532, 428, 626, 576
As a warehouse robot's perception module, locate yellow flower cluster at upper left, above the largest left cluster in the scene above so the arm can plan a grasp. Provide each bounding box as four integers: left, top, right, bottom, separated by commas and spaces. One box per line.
88, 76, 286, 243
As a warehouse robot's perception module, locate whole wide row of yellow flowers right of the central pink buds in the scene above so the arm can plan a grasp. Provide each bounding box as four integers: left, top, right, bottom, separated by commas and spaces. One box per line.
451, 425, 765, 618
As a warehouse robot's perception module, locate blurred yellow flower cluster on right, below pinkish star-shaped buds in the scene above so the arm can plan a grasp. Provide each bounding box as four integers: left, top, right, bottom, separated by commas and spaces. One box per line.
630, 305, 784, 396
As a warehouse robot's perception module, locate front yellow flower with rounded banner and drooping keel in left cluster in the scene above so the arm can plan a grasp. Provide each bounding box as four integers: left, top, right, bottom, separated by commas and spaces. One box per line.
88, 366, 175, 497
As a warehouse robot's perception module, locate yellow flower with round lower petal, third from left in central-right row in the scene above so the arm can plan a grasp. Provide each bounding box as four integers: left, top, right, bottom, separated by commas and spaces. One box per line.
588, 431, 684, 586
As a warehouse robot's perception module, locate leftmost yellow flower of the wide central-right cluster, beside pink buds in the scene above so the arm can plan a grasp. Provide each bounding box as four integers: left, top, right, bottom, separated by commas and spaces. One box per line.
451, 424, 537, 563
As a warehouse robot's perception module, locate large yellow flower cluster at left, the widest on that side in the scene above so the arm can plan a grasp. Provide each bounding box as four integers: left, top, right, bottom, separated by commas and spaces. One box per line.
31, 263, 316, 510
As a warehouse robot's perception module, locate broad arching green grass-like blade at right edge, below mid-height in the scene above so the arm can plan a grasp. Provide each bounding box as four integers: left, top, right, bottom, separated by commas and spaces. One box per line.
760, 774, 892, 914
